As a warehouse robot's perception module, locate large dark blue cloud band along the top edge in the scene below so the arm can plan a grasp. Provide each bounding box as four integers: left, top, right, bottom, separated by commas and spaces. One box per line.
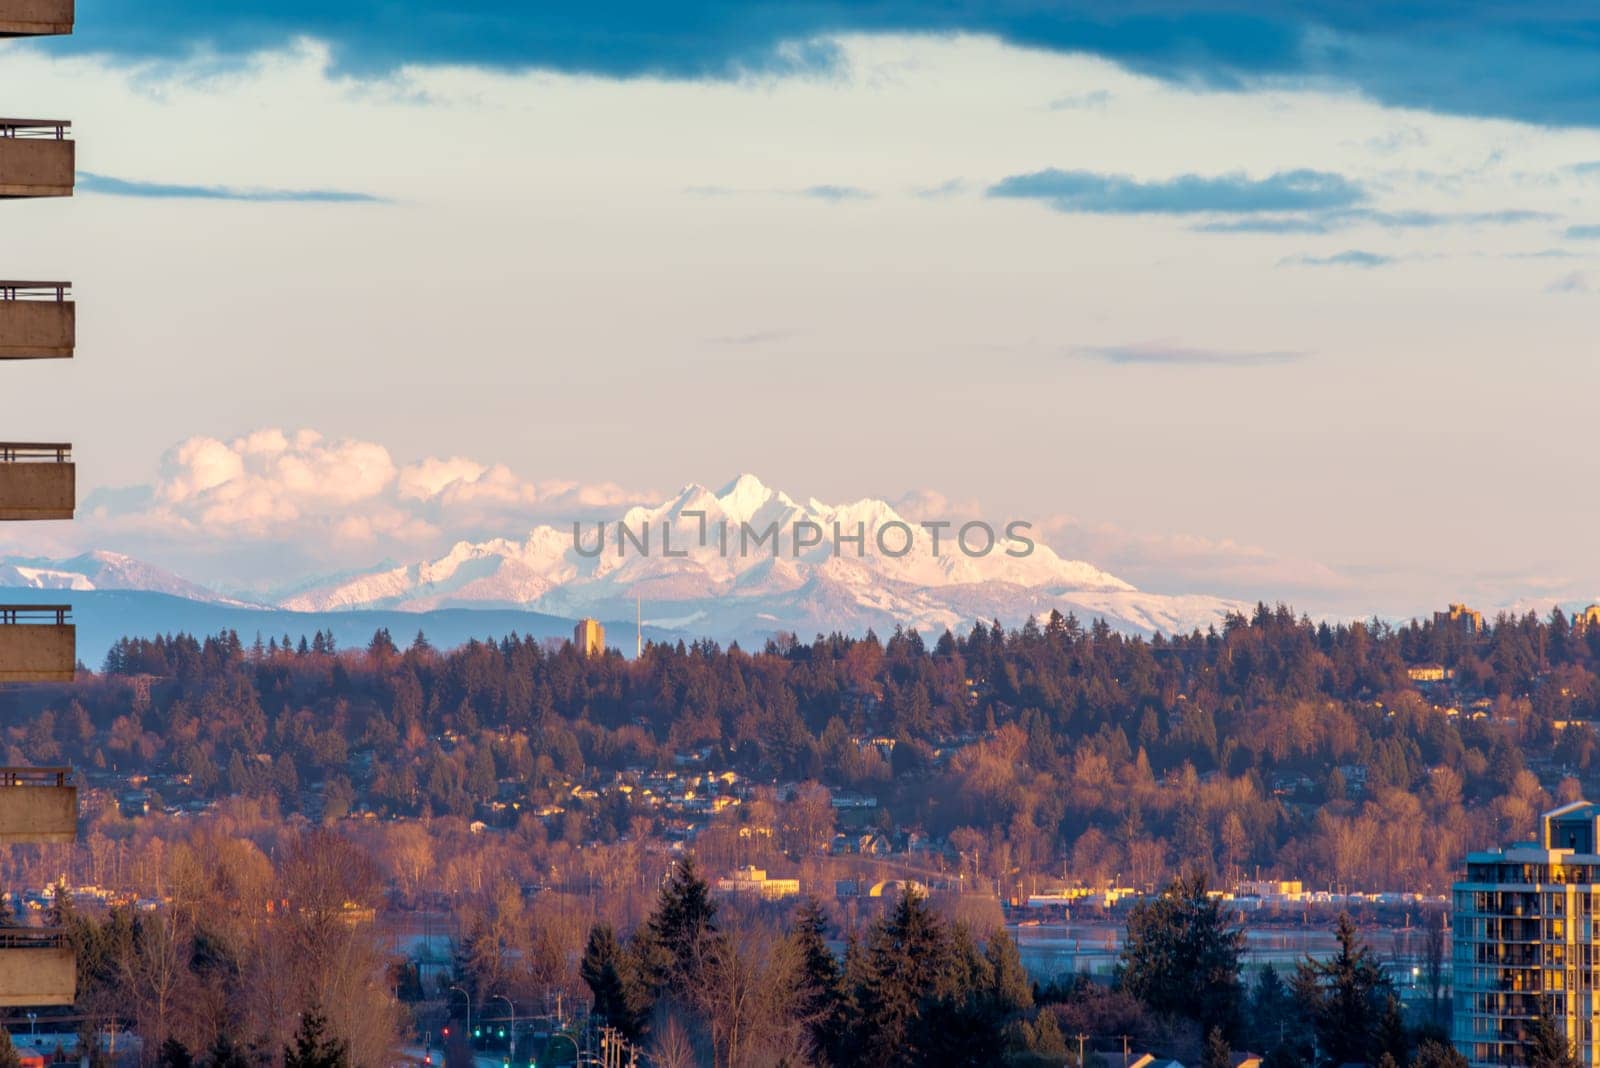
50, 0, 1600, 126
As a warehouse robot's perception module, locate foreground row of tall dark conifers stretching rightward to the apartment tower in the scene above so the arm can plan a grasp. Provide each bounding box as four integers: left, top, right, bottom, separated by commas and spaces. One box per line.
581, 855, 1578, 1068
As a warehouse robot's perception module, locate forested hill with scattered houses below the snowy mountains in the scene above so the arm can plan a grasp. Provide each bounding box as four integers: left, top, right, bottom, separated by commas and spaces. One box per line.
0, 606, 1600, 889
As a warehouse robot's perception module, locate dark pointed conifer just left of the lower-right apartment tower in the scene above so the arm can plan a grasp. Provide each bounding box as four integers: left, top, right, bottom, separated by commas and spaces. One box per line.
1293, 913, 1394, 1065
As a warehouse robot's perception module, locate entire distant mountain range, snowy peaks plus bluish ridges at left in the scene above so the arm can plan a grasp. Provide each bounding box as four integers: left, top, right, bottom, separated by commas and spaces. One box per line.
0, 475, 1248, 658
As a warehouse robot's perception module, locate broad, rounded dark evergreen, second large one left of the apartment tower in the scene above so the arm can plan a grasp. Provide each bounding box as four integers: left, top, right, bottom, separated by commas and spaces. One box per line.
1117, 870, 1245, 1036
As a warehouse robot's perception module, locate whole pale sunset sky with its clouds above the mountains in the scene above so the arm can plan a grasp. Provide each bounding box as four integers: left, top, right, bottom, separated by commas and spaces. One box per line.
0, 0, 1600, 617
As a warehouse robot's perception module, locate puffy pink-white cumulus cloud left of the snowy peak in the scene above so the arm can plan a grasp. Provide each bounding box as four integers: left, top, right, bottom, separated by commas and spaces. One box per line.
74, 427, 651, 585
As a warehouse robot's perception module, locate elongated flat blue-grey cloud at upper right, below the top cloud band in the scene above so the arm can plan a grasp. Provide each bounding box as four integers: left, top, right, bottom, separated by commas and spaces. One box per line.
989, 168, 1366, 214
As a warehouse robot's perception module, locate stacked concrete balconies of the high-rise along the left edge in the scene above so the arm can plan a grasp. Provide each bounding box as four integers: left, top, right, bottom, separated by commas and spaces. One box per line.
0, 0, 78, 1007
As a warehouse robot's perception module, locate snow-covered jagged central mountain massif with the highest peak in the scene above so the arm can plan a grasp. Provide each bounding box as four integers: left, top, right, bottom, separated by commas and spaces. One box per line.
280, 475, 1243, 640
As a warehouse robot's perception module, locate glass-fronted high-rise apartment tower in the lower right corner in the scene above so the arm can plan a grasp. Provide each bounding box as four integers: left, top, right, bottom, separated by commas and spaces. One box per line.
1451, 801, 1600, 1066
